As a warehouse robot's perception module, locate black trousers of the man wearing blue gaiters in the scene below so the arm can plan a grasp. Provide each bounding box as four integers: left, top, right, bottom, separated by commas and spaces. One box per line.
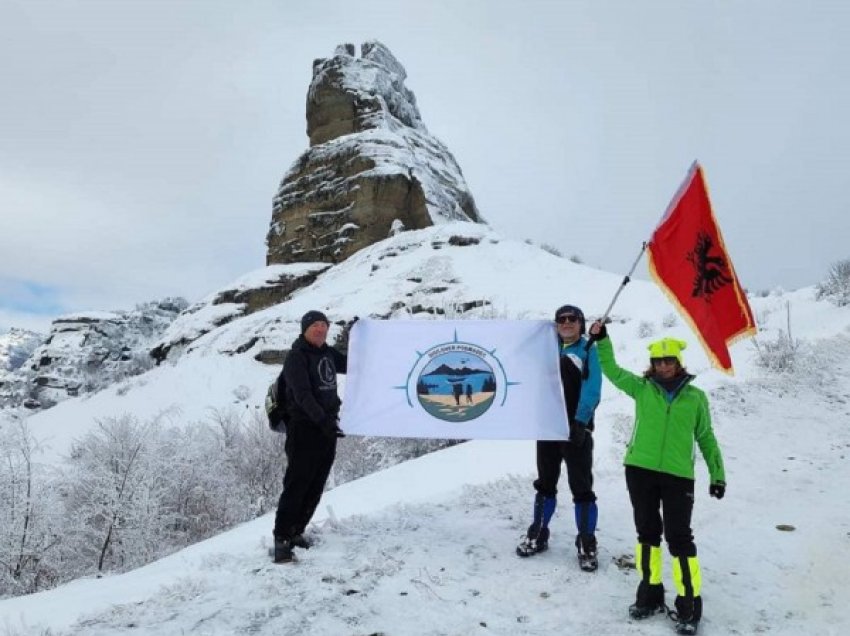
534, 432, 596, 503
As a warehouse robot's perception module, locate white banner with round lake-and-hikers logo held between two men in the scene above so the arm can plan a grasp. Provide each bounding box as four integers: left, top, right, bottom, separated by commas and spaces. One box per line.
334, 319, 569, 440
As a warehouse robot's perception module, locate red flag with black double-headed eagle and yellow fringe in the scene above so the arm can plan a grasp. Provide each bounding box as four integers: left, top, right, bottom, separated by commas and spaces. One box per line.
648, 162, 756, 374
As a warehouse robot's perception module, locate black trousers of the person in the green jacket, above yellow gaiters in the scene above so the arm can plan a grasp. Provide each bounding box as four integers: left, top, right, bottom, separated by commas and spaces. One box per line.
626, 466, 697, 557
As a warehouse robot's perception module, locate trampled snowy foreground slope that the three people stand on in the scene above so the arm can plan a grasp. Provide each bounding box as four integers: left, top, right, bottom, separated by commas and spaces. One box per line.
0, 336, 850, 635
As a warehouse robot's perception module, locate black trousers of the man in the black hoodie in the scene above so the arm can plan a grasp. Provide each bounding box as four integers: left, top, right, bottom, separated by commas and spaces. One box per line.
274, 426, 336, 538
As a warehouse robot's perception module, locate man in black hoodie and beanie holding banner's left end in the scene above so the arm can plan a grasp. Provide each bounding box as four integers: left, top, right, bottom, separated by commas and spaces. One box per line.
274, 310, 348, 563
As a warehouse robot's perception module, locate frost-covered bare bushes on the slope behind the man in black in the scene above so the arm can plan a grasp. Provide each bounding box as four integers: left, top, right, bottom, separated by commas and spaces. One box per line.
0, 408, 457, 596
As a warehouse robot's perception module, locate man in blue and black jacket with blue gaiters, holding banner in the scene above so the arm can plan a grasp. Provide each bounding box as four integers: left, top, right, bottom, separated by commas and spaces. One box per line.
516, 305, 602, 572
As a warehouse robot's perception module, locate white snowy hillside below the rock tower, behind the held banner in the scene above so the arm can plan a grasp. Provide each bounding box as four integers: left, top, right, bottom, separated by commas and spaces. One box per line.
21, 223, 684, 461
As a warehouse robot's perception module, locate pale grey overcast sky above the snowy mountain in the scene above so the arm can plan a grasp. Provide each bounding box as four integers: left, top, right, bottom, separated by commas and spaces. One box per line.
0, 0, 850, 331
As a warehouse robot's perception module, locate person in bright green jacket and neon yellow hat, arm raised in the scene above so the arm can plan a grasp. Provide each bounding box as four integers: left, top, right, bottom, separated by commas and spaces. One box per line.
590, 321, 726, 634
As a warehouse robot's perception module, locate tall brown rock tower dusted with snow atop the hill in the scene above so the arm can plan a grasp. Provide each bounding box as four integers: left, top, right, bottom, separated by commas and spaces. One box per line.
266, 42, 476, 264
